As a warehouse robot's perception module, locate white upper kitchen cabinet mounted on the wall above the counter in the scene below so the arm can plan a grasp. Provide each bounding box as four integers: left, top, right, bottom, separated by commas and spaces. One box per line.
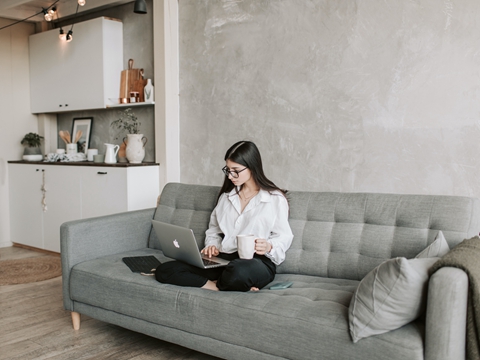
29, 17, 123, 113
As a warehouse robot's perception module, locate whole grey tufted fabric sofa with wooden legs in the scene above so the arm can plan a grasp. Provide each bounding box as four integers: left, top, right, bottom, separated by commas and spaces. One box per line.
61, 183, 480, 360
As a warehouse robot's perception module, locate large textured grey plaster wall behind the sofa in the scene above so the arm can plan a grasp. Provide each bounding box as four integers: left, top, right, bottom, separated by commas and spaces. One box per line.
179, 0, 480, 196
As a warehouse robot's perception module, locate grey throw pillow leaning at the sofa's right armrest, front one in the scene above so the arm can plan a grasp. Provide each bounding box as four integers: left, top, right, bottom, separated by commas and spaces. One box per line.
348, 257, 438, 343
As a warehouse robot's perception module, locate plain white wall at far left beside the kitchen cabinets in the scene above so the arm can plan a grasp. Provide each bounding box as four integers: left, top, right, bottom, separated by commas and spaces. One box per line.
0, 18, 38, 247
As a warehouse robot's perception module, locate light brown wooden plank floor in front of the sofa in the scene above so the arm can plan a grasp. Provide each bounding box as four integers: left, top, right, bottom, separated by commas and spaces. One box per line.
0, 247, 218, 360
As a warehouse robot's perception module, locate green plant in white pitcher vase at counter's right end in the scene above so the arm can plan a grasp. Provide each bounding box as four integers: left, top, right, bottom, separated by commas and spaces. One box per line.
110, 108, 147, 164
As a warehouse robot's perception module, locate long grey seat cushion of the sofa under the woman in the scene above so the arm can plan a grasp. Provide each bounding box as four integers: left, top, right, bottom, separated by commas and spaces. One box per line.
70, 249, 424, 359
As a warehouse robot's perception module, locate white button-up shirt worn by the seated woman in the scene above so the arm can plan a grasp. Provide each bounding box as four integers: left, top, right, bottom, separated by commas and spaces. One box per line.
205, 189, 293, 265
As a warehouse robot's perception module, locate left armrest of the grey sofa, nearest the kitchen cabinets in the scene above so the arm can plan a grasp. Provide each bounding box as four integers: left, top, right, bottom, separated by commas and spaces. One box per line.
60, 209, 155, 311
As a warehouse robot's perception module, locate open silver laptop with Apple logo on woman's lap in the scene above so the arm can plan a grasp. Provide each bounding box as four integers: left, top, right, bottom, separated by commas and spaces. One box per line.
152, 220, 230, 269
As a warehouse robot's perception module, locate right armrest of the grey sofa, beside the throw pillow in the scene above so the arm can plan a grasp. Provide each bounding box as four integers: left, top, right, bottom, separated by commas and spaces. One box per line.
425, 267, 468, 360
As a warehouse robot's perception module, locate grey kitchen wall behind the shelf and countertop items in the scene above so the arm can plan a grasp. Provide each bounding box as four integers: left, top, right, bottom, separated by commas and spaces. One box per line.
57, 0, 155, 161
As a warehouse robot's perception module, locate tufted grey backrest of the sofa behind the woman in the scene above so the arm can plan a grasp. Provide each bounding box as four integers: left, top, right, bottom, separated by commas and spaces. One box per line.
150, 183, 480, 280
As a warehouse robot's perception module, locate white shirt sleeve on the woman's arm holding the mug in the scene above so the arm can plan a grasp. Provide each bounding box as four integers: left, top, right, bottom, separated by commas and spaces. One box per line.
265, 195, 293, 265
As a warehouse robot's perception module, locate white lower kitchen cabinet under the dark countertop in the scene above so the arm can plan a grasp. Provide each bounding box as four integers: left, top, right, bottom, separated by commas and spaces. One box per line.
8, 162, 159, 252
